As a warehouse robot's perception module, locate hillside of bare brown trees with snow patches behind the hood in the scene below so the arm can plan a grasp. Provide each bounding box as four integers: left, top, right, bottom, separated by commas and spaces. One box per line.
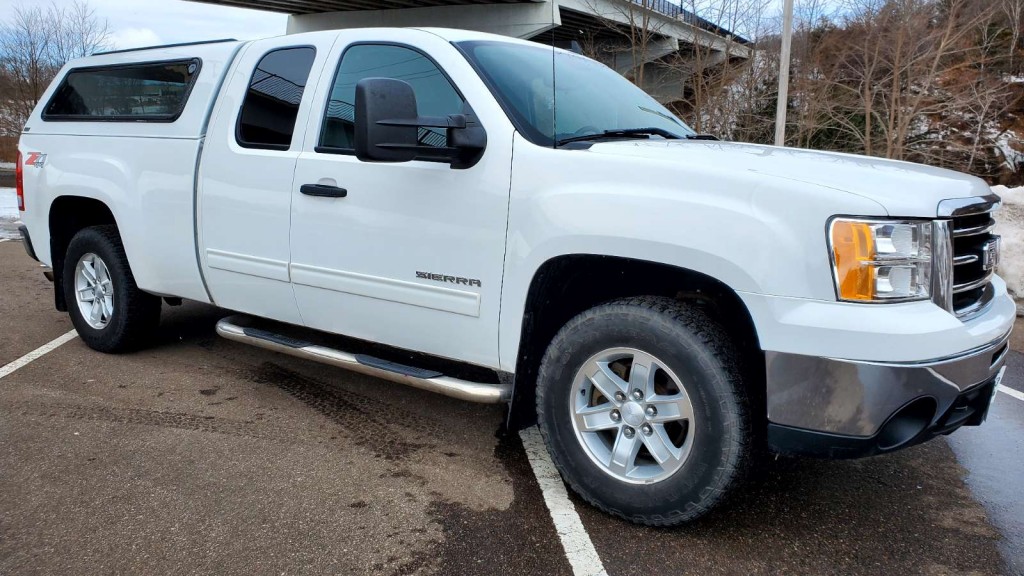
667, 0, 1024, 186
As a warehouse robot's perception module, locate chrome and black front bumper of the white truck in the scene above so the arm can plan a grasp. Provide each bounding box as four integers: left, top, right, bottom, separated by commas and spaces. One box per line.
766, 332, 1010, 458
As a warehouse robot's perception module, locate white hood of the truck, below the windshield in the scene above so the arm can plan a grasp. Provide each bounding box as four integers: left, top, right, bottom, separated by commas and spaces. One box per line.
589, 140, 991, 217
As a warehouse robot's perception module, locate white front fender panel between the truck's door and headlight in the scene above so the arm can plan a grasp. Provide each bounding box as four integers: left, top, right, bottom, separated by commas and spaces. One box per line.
499, 136, 885, 371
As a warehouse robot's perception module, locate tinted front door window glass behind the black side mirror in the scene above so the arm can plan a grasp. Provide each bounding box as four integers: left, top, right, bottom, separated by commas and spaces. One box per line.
321, 44, 464, 152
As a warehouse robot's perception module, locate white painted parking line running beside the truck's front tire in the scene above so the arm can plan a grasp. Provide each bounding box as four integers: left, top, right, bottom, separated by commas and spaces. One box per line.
519, 426, 608, 576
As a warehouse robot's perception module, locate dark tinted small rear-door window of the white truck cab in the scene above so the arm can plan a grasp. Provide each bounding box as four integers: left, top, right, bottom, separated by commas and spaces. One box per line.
238, 47, 316, 150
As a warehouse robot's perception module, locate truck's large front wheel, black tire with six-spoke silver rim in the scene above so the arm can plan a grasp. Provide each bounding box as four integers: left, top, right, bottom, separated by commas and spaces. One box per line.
537, 296, 752, 526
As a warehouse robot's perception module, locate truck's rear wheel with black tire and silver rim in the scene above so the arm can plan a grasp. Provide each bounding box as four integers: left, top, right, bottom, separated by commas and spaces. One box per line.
62, 225, 161, 354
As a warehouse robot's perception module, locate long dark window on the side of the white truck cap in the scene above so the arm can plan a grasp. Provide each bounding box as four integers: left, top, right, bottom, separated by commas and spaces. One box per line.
43, 59, 200, 122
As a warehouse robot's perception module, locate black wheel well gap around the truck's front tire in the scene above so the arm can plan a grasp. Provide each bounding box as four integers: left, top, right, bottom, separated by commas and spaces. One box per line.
509, 254, 766, 428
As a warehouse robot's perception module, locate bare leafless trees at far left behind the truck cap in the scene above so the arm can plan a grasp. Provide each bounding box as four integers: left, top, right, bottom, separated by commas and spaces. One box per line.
0, 0, 110, 137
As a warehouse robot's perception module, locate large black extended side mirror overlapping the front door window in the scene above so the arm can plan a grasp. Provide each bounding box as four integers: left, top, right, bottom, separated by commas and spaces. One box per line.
355, 78, 487, 168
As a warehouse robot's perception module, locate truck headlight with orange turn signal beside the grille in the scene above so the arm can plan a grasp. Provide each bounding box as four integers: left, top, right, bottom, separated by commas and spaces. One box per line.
828, 218, 932, 302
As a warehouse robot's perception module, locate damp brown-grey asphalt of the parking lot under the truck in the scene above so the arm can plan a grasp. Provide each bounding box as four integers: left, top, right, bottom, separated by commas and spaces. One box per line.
0, 236, 1024, 576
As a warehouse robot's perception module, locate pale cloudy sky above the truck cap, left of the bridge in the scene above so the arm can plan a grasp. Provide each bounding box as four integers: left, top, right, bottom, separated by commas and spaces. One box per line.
0, 0, 288, 48
